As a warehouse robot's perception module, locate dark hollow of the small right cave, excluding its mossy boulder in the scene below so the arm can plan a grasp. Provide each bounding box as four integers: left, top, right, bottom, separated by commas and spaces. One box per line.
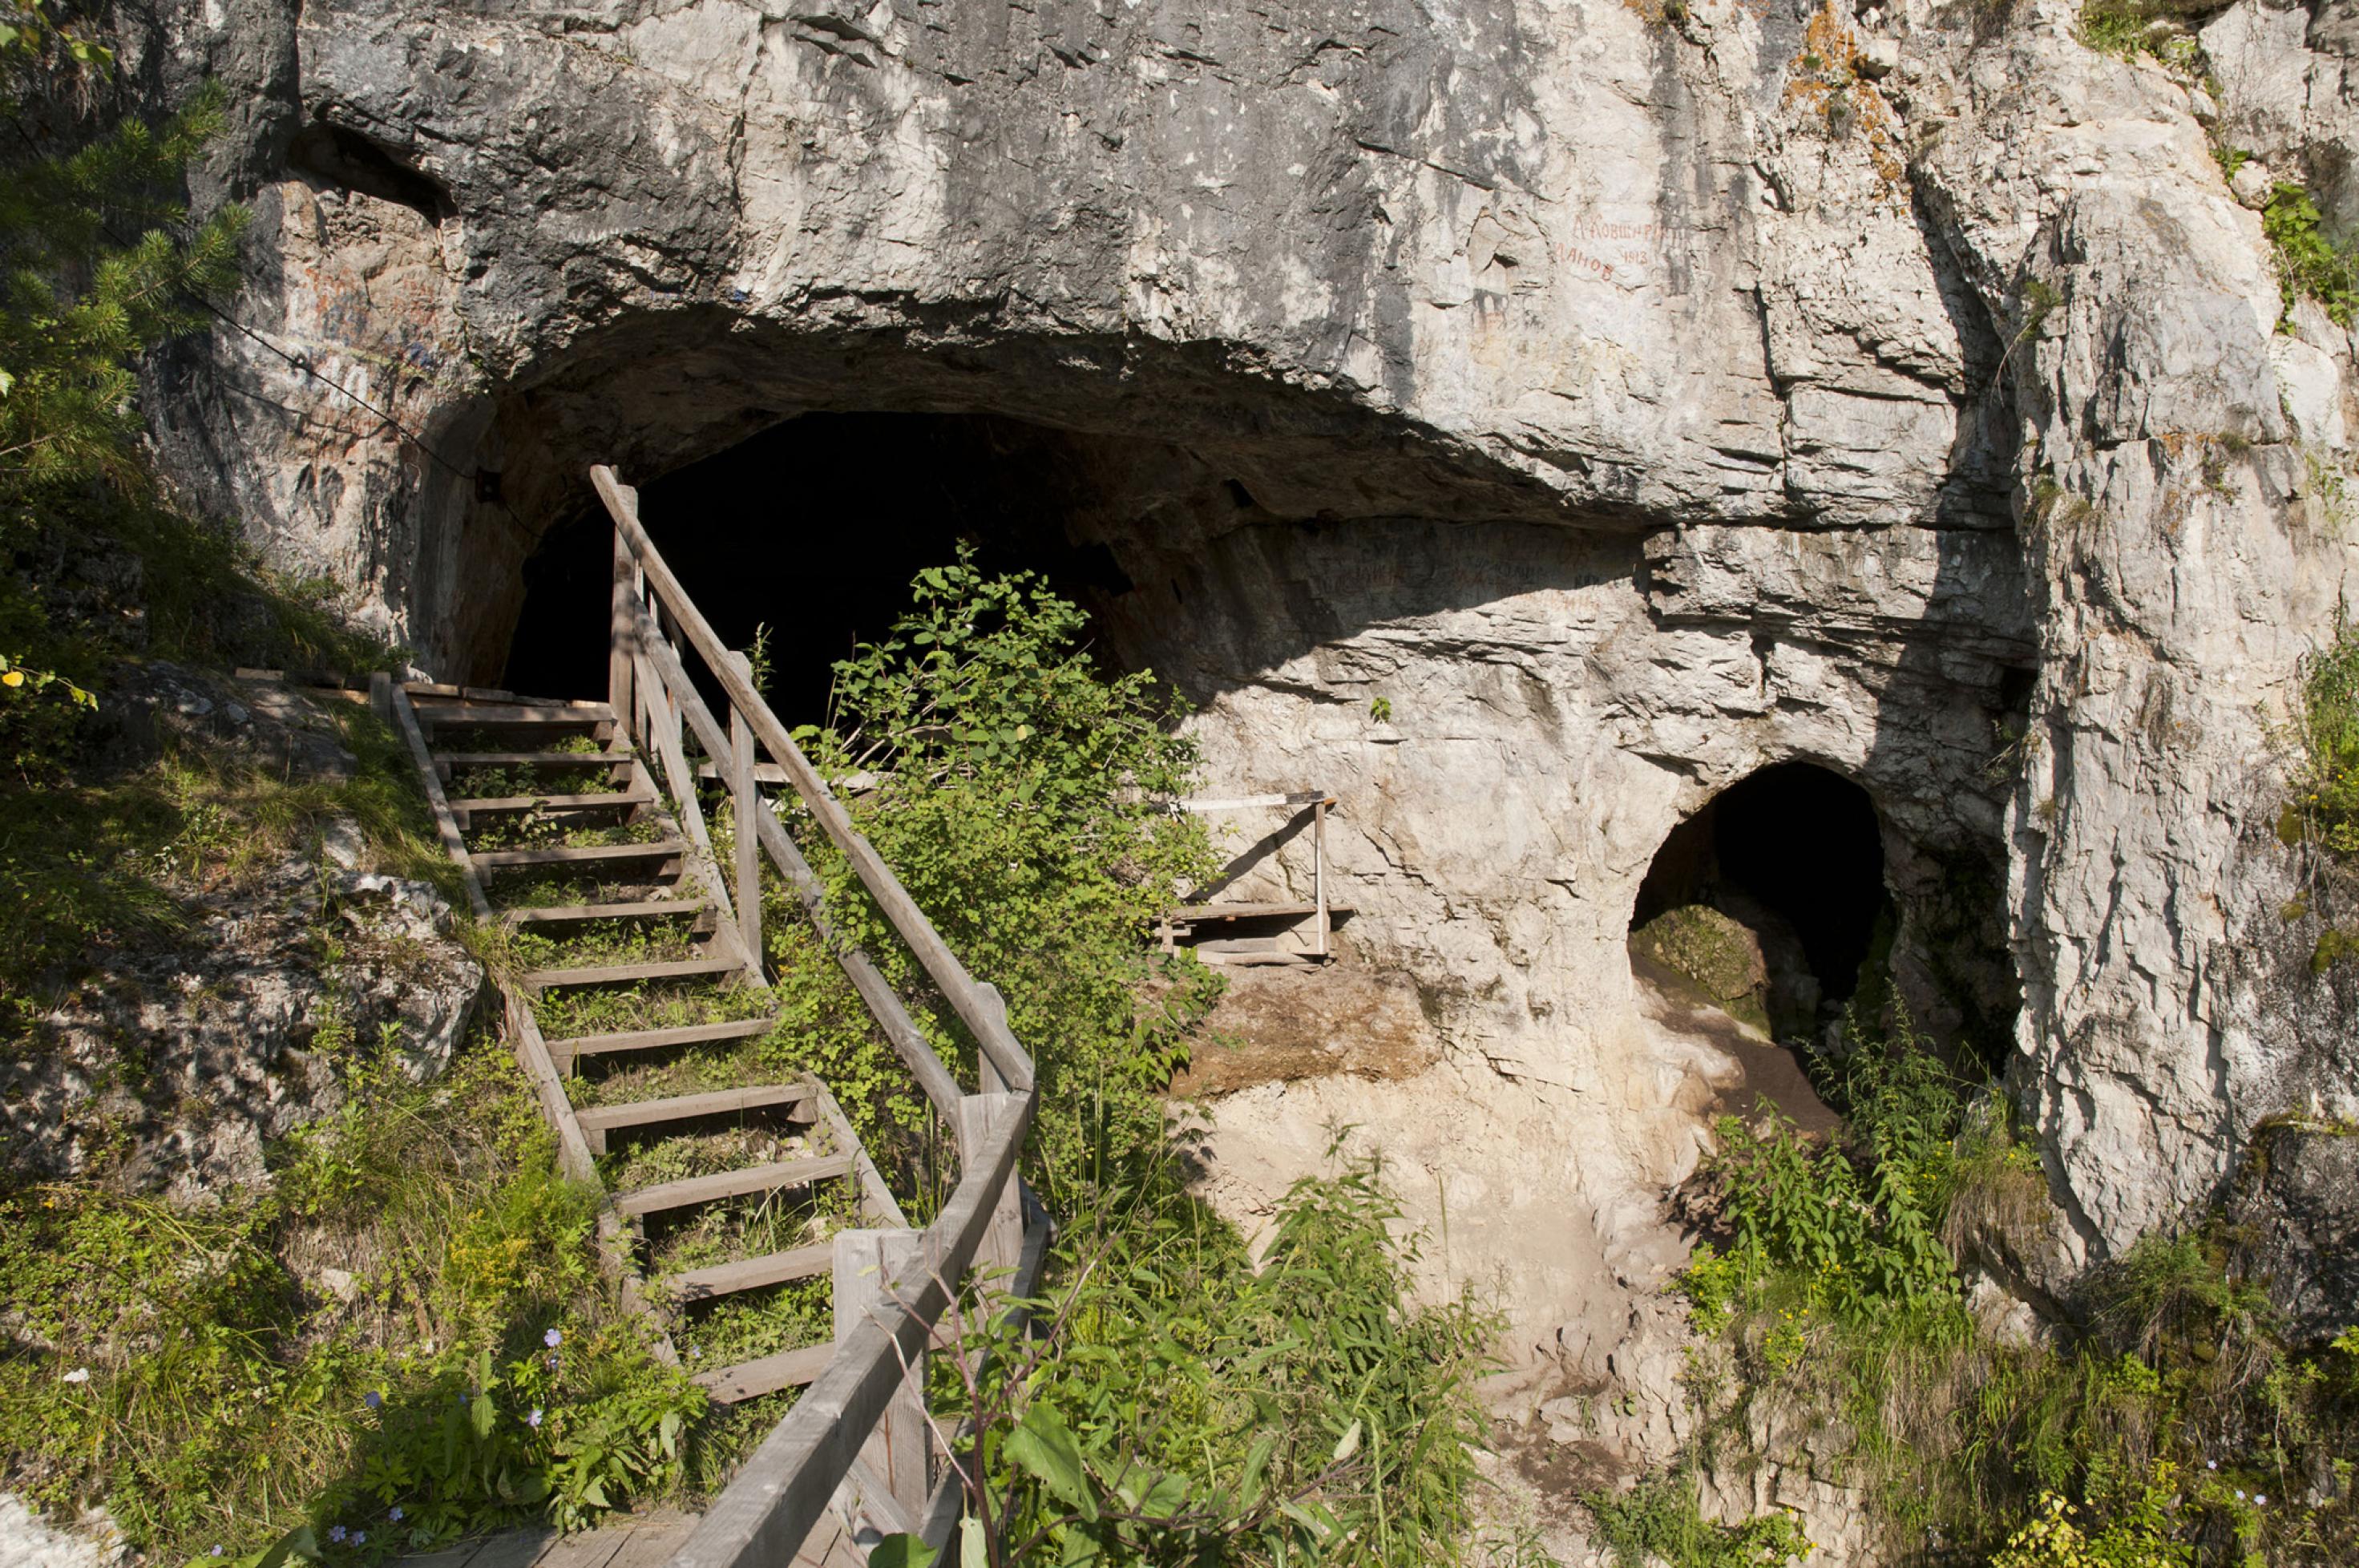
1630, 762, 1892, 1024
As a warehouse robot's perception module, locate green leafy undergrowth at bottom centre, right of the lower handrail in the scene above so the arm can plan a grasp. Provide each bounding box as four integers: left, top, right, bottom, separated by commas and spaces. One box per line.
890, 1162, 1496, 1568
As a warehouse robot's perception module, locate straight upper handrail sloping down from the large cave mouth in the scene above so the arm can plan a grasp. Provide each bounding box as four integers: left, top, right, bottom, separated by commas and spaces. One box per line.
590, 464, 1033, 1092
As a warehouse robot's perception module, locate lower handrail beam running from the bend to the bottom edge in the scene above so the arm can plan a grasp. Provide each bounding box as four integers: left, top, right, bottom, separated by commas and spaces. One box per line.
673, 1094, 1033, 1568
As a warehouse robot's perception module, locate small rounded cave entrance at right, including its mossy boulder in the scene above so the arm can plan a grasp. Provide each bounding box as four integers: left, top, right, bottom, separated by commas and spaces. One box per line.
1630, 762, 1894, 1040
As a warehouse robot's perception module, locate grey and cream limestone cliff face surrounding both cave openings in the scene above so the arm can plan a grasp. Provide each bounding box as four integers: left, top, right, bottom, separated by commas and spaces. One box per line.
111, 0, 2359, 1318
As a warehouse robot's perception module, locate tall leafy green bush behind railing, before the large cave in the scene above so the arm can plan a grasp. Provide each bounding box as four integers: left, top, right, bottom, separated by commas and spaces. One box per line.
800, 552, 1218, 1193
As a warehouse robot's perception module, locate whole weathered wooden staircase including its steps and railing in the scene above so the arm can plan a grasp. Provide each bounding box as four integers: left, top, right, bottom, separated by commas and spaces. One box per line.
370, 467, 1050, 1568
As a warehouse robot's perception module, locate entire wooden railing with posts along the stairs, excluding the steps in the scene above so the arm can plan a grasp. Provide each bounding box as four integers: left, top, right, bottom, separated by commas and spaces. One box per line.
590, 464, 1048, 1568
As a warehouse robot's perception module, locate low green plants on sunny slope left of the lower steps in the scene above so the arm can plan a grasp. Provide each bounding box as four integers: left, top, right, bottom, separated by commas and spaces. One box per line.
0, 1030, 705, 1563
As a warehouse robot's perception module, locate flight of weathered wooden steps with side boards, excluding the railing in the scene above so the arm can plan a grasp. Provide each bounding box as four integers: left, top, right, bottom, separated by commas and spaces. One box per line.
382, 684, 908, 1403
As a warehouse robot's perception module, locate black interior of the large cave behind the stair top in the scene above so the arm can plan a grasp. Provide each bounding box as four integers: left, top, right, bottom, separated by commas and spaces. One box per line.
500, 413, 1130, 724
